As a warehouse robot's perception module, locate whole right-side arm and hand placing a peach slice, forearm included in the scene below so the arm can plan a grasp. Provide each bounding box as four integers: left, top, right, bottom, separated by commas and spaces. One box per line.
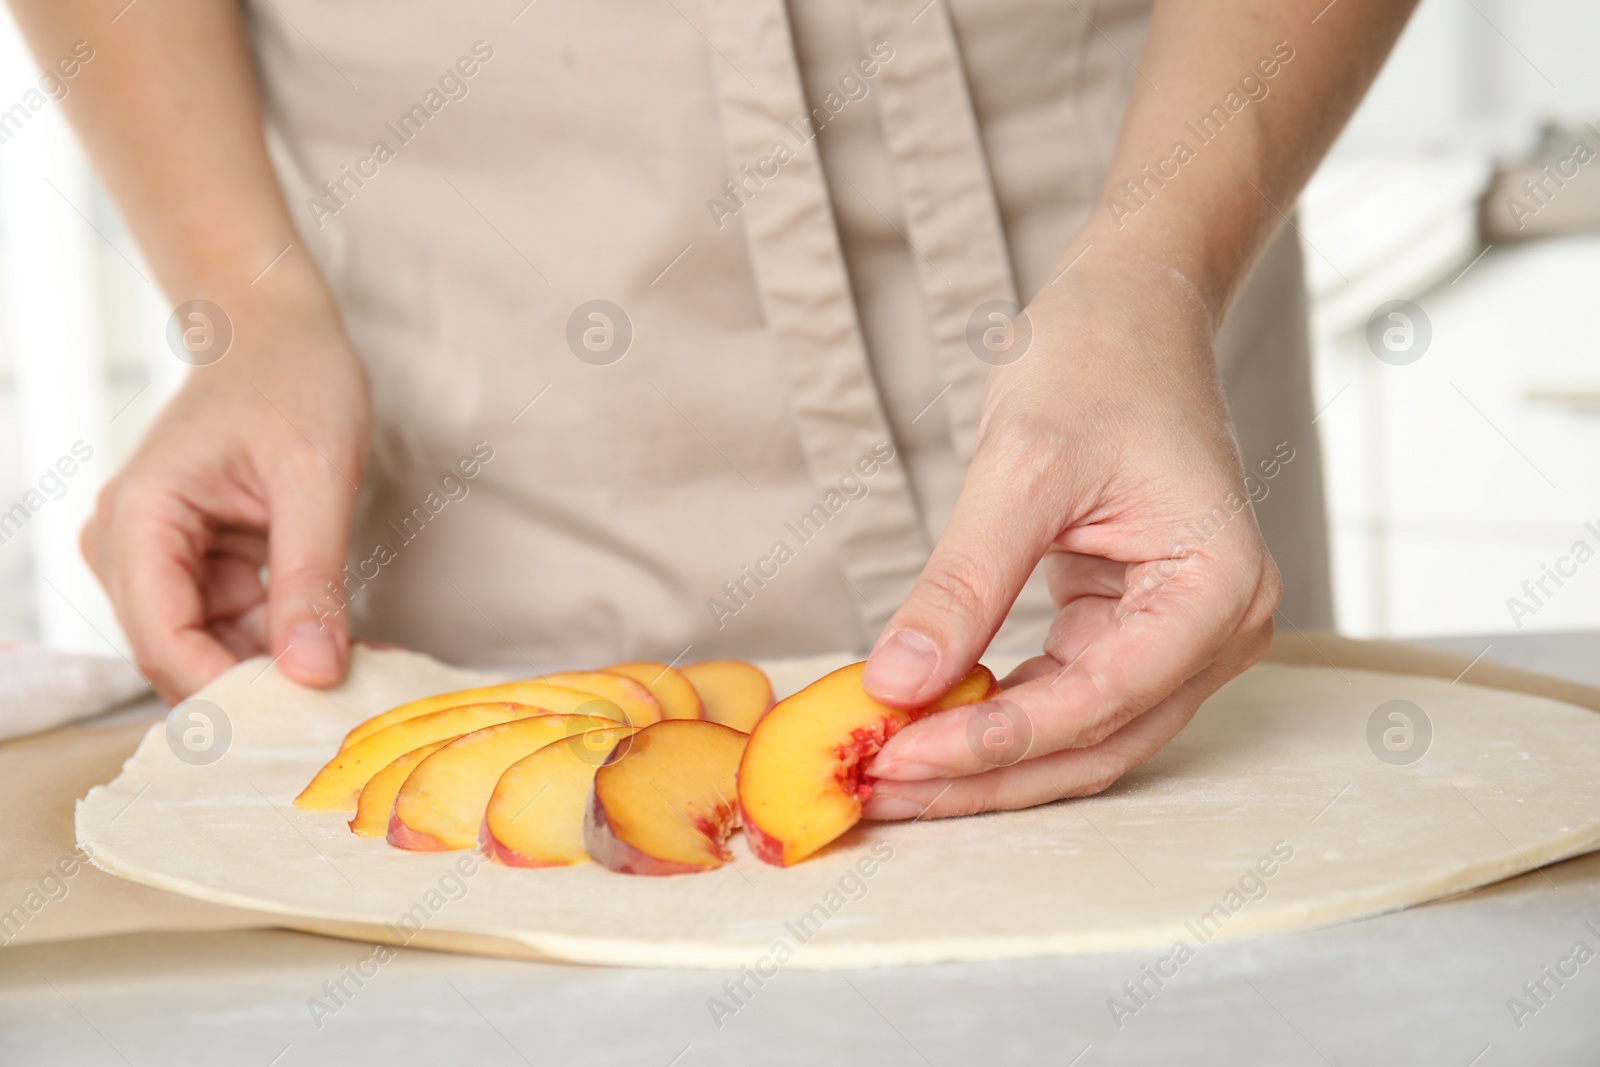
862, 0, 1414, 819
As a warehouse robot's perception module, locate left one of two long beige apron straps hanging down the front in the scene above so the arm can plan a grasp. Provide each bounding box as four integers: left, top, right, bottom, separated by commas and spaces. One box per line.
701, 0, 930, 643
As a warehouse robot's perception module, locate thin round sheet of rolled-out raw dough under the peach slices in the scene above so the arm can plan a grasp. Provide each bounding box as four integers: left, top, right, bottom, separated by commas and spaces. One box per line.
77, 648, 1600, 969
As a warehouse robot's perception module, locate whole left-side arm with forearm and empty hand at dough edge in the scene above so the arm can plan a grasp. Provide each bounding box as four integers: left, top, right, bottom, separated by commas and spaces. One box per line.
8, 0, 371, 702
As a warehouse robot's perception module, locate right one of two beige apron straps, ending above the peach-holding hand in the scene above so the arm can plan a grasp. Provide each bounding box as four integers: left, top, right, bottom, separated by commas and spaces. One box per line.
858, 0, 1018, 459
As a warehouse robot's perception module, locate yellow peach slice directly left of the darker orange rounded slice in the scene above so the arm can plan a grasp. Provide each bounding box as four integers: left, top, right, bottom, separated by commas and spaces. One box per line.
478, 726, 637, 867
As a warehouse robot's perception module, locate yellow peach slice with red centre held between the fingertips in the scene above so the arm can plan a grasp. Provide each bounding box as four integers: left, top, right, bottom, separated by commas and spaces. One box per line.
739, 662, 1000, 867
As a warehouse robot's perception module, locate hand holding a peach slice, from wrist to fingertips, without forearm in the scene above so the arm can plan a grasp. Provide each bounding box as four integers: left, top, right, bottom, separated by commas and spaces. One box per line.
864, 253, 1282, 819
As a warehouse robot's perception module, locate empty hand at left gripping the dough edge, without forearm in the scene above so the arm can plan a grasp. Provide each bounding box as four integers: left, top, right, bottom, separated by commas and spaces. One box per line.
82, 287, 371, 704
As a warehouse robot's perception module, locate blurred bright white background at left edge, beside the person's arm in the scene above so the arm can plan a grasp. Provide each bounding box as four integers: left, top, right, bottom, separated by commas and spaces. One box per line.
0, 6, 181, 653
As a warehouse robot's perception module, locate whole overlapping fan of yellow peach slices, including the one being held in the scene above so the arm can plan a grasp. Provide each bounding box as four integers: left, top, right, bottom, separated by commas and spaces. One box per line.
294, 659, 998, 875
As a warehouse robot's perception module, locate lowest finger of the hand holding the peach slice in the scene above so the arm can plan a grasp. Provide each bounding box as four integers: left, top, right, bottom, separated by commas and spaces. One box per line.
861, 655, 1214, 821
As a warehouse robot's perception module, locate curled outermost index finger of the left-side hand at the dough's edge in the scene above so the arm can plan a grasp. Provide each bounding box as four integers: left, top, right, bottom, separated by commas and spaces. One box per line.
109, 494, 238, 704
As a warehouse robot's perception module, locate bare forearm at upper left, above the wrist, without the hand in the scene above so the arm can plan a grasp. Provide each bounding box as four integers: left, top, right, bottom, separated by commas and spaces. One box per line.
10, 0, 326, 315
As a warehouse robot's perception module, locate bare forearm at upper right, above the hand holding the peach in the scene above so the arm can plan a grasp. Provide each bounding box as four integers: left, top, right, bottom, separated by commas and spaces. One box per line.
1066, 0, 1414, 319
